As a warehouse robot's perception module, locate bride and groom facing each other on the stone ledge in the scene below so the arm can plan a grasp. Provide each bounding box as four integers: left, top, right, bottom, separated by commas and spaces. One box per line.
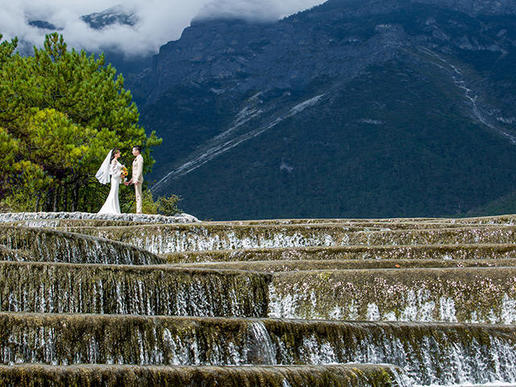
95, 146, 143, 215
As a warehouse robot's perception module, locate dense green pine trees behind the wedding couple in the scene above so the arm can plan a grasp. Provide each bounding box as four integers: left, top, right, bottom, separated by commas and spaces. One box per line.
0, 33, 161, 211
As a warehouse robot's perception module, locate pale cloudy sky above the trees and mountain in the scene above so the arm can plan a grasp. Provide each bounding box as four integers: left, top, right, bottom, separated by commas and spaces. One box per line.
0, 0, 325, 56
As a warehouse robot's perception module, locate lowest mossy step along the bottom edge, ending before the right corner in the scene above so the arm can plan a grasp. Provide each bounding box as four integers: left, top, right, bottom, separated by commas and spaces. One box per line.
0, 364, 411, 387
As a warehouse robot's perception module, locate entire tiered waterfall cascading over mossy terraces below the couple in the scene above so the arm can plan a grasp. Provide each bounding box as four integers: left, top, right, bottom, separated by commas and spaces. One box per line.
0, 217, 516, 387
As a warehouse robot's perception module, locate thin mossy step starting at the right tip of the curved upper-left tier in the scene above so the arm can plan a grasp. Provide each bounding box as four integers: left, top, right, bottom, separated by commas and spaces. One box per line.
162, 243, 516, 263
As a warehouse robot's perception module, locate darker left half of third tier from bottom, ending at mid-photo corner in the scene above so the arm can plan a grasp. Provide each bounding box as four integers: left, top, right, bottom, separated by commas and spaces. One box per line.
0, 262, 271, 317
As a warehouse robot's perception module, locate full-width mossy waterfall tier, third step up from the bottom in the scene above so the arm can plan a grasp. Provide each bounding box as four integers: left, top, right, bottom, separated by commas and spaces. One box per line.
0, 262, 516, 324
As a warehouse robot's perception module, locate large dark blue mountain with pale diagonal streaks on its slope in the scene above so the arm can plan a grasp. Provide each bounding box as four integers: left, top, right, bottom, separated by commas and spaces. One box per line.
127, 0, 516, 219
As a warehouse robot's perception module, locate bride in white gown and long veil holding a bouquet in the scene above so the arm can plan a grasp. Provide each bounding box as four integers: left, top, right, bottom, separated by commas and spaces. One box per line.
95, 148, 124, 214
